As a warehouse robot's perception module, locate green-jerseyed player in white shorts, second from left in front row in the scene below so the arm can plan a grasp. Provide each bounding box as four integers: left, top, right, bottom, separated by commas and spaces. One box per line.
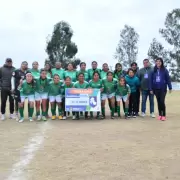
35, 69, 51, 121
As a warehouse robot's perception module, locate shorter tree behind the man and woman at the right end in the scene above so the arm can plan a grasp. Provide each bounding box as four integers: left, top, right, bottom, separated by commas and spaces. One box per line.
148, 38, 171, 66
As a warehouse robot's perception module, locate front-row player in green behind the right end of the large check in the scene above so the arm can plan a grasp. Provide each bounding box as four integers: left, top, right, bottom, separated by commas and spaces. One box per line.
89, 72, 103, 119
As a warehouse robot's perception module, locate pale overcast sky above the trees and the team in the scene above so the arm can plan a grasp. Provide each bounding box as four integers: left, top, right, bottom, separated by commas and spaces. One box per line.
0, 0, 180, 67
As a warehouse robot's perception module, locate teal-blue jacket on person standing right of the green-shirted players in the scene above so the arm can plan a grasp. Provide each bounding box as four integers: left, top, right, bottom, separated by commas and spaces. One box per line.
125, 75, 140, 93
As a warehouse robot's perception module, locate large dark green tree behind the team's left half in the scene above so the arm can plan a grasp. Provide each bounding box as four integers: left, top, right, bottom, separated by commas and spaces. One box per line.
46, 21, 78, 67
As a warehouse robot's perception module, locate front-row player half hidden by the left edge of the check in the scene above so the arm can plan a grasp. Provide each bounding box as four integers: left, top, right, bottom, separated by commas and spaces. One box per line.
62, 76, 76, 120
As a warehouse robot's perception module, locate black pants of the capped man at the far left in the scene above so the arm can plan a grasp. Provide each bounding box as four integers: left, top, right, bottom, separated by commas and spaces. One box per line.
1, 89, 14, 114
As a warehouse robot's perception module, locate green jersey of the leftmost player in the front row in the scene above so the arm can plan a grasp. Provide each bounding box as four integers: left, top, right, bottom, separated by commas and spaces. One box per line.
19, 81, 35, 96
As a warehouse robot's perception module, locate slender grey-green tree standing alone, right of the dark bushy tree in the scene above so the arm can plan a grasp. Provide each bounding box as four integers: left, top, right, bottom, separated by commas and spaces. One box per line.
114, 25, 139, 68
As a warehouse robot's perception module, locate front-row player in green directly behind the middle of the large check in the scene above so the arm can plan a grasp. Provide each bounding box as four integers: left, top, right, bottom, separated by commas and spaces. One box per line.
74, 73, 89, 120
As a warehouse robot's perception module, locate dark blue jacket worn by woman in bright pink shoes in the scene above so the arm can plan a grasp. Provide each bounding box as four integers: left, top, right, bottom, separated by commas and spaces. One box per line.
149, 67, 172, 91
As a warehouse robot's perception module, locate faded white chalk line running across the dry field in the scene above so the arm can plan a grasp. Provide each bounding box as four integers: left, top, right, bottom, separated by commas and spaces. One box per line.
7, 123, 48, 180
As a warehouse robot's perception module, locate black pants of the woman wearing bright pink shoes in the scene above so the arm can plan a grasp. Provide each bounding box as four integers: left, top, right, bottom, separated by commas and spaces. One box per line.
154, 89, 167, 116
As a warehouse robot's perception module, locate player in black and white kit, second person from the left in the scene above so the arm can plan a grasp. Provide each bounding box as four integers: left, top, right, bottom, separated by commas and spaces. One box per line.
11, 61, 28, 118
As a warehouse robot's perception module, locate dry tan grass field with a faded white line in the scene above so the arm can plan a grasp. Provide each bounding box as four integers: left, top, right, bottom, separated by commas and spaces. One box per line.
0, 92, 180, 180
